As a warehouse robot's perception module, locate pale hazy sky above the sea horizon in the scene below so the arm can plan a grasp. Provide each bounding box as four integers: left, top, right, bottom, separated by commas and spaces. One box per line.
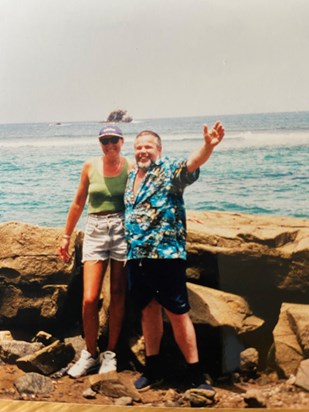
0, 0, 309, 123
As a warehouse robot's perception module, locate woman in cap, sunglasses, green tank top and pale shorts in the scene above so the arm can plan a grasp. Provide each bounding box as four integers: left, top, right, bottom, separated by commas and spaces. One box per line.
59, 126, 130, 378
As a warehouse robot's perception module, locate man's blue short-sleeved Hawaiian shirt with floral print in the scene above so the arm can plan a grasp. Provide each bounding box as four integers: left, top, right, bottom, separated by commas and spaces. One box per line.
124, 157, 199, 260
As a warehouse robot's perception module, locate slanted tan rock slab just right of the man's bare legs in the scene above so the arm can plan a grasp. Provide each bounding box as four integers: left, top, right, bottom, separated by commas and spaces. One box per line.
187, 283, 264, 333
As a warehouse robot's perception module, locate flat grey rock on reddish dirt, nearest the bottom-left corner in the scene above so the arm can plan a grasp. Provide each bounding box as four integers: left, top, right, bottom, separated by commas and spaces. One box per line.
14, 373, 54, 395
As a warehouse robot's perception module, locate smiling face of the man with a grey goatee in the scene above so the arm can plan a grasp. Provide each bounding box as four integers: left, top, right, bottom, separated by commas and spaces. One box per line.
134, 135, 162, 170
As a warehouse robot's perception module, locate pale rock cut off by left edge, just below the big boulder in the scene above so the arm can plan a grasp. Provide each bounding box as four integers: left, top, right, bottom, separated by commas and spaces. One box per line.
0, 340, 44, 363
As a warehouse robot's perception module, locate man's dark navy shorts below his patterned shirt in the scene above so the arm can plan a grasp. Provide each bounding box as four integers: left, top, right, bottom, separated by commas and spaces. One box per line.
127, 259, 190, 314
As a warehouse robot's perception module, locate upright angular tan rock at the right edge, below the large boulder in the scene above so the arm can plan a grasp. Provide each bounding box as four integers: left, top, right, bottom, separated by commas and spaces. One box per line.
273, 303, 309, 378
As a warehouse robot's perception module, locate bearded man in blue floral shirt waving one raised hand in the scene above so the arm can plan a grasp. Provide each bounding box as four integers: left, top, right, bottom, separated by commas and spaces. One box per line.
125, 122, 224, 390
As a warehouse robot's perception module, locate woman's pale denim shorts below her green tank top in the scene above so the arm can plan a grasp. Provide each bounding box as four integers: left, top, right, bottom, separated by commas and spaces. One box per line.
82, 213, 127, 262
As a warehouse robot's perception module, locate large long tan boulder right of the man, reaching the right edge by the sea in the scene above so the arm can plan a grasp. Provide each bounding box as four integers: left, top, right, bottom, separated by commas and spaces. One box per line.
187, 211, 309, 359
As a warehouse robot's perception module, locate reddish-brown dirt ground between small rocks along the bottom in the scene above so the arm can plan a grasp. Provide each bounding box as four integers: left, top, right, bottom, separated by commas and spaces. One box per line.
0, 364, 309, 411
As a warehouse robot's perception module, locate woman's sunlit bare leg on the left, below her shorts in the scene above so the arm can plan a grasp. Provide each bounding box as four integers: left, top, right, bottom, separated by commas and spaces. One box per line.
82, 261, 108, 356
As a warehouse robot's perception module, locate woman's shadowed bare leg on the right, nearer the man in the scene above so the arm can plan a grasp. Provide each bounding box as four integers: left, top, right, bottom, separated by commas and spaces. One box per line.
107, 259, 126, 352
